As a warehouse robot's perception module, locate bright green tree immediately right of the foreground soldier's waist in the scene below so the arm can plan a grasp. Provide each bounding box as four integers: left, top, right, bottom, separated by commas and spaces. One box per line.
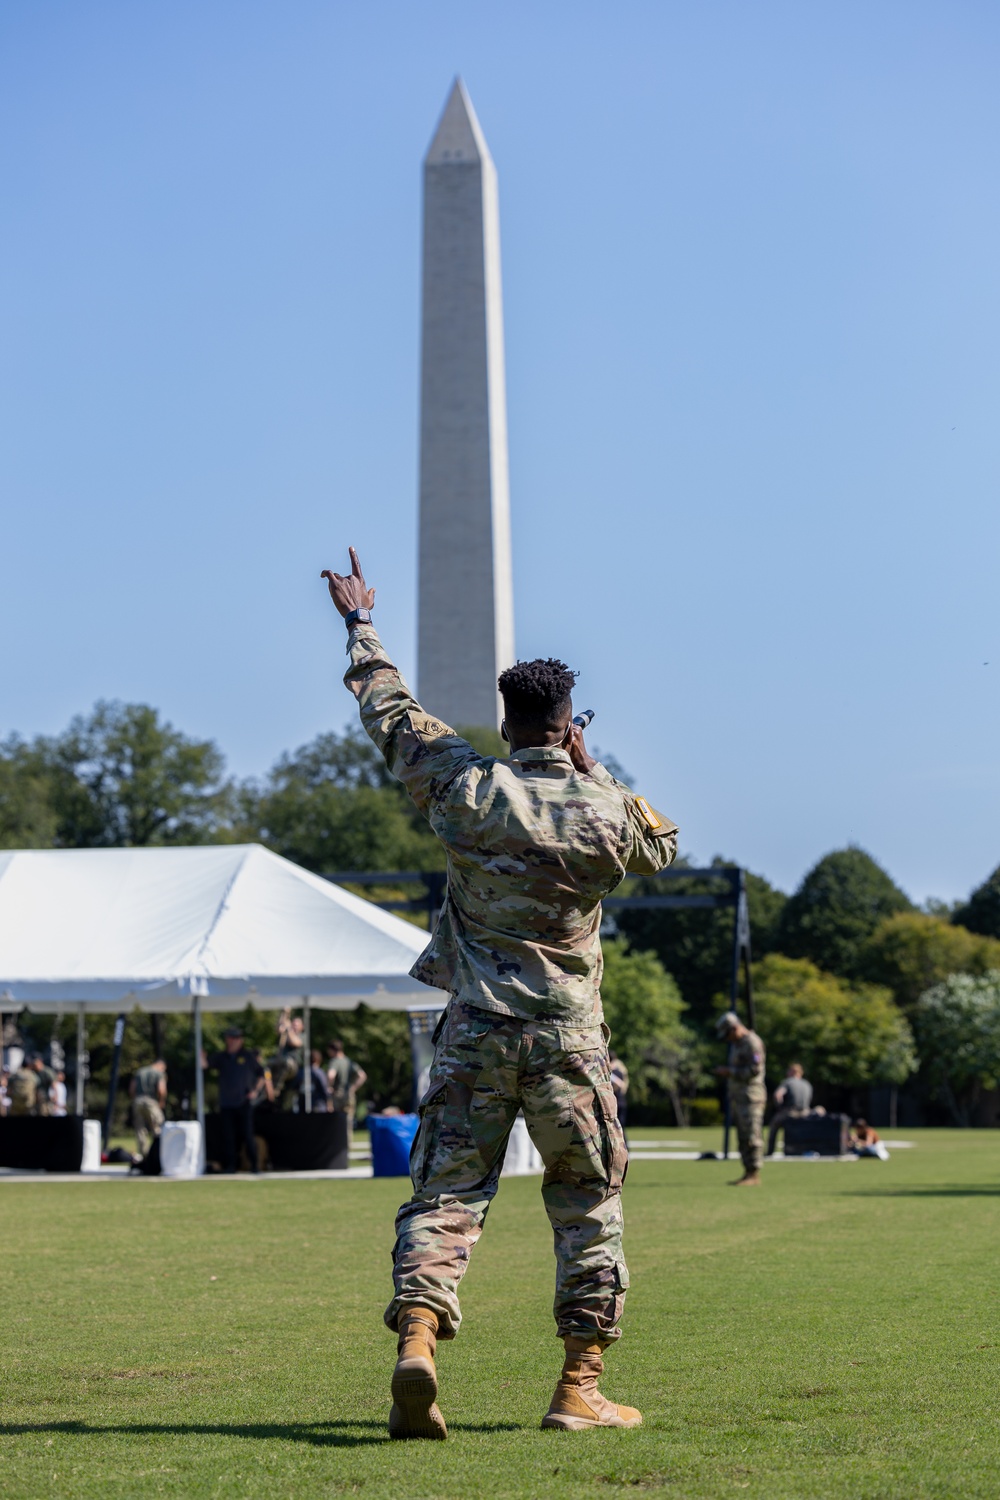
601, 938, 699, 1125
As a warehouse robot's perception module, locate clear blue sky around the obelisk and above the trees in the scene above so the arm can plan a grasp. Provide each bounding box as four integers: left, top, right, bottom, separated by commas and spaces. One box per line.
0, 0, 1000, 899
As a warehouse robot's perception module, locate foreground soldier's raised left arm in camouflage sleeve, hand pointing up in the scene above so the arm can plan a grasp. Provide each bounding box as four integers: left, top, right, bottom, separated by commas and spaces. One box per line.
322, 548, 480, 813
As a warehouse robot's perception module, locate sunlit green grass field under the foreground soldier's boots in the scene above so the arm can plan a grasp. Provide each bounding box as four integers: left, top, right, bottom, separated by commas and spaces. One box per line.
0, 1130, 1000, 1500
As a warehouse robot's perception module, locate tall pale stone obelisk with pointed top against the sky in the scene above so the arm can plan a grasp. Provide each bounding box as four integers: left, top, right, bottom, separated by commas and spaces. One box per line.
417, 80, 514, 726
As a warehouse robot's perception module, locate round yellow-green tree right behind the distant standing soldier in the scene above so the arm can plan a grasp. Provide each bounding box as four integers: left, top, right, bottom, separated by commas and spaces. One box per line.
749, 953, 916, 1088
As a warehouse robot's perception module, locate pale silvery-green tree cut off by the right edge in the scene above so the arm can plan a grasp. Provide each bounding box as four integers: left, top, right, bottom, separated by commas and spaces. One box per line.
913, 969, 1000, 1125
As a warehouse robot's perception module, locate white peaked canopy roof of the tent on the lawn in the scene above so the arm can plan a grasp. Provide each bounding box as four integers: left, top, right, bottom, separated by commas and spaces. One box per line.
0, 845, 444, 1013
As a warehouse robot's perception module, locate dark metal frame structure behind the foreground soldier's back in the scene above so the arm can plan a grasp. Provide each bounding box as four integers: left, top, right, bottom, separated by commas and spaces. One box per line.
327, 864, 756, 1157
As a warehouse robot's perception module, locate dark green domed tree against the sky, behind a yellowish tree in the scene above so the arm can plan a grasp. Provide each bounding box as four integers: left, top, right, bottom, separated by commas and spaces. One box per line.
775, 848, 913, 980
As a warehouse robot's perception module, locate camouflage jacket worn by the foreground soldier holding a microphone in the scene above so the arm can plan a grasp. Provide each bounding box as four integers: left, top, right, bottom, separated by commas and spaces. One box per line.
345, 626, 678, 1025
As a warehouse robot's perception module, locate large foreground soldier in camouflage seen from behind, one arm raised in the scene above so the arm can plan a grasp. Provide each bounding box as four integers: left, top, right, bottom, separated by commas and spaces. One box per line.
324, 549, 676, 1437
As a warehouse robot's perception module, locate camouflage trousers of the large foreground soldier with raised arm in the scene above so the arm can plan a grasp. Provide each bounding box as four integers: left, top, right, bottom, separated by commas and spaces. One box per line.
385, 1001, 628, 1343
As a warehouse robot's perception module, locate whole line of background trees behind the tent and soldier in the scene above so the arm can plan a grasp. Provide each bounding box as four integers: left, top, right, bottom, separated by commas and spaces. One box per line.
0, 702, 1000, 1124
